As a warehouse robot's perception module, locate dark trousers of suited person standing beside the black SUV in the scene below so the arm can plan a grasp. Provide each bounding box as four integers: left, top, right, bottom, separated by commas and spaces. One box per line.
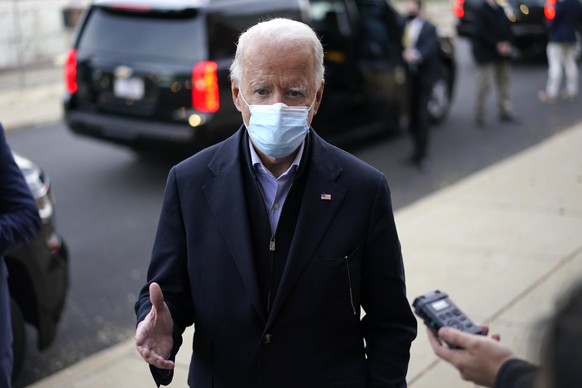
408, 76, 431, 161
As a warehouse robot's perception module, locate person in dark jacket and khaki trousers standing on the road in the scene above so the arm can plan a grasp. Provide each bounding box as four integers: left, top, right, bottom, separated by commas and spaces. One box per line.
473, 0, 517, 127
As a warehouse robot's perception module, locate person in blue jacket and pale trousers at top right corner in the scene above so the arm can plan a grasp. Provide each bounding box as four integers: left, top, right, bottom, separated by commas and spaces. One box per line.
538, 0, 582, 103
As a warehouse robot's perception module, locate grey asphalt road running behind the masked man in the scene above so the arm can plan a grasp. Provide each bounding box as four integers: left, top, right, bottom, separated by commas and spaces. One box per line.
8, 40, 582, 387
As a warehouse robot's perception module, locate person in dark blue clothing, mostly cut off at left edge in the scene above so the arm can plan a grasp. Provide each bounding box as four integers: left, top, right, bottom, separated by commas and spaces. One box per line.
0, 125, 40, 387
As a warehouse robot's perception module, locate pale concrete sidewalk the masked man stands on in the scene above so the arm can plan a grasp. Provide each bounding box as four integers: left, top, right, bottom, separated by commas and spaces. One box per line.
26, 120, 582, 388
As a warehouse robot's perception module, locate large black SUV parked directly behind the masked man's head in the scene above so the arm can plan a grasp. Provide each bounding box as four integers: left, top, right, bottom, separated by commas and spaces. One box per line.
65, 0, 455, 152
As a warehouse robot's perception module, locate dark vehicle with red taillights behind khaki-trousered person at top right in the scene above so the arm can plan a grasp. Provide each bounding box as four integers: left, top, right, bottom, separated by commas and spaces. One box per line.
453, 0, 553, 57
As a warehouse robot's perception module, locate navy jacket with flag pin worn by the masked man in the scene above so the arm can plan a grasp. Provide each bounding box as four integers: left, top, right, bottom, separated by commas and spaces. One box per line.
136, 127, 416, 388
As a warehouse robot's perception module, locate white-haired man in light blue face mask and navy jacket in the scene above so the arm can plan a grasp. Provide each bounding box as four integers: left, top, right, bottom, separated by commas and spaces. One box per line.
135, 19, 416, 388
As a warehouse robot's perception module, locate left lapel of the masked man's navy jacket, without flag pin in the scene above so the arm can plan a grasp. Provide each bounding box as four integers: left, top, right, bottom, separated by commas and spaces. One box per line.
203, 131, 266, 321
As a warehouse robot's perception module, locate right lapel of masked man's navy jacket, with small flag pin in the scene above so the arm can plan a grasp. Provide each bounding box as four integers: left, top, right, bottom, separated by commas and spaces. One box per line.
267, 131, 346, 326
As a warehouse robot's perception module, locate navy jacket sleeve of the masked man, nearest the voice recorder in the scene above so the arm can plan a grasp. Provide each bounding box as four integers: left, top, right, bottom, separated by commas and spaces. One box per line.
362, 176, 416, 388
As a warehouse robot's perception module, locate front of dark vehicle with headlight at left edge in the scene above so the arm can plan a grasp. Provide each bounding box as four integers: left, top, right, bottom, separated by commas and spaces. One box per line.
4, 154, 69, 376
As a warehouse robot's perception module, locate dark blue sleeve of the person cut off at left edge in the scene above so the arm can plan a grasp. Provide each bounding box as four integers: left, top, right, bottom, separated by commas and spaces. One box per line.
0, 125, 40, 256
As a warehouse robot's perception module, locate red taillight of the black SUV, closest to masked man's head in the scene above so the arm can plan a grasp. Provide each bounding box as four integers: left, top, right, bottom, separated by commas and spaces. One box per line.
192, 61, 220, 113
